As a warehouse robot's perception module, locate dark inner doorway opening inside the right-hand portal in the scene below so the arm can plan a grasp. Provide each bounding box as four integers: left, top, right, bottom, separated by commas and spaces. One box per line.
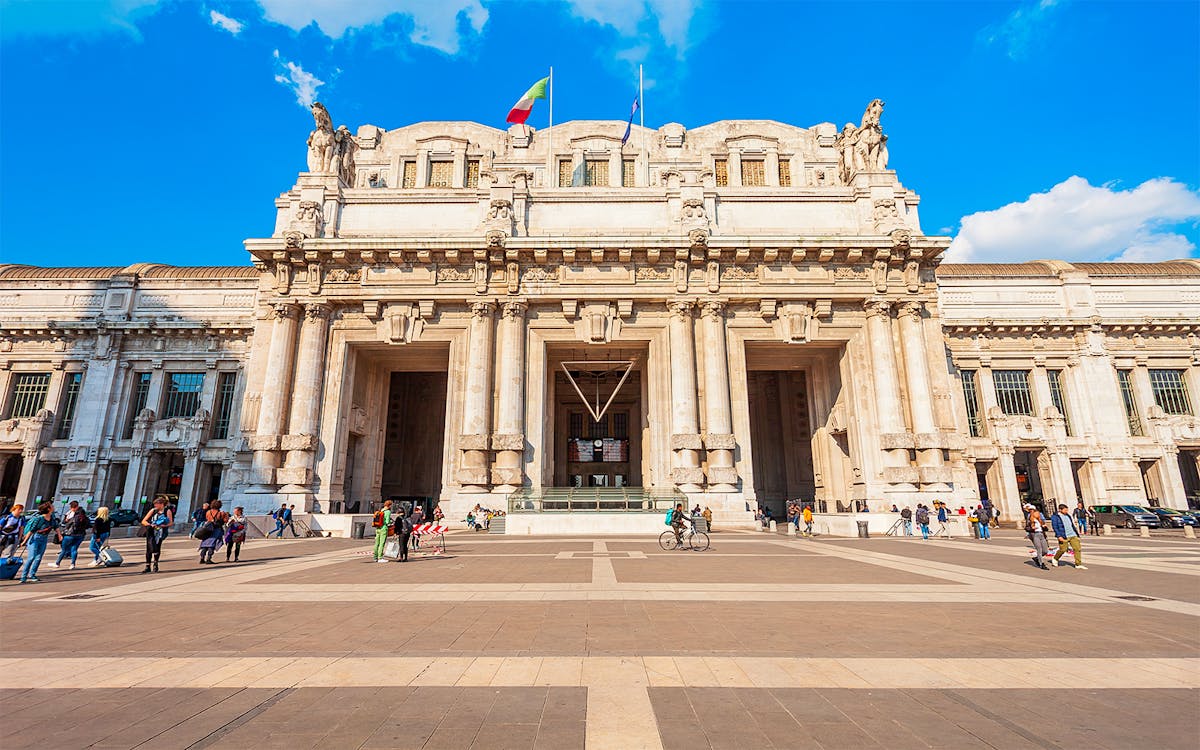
746, 370, 816, 518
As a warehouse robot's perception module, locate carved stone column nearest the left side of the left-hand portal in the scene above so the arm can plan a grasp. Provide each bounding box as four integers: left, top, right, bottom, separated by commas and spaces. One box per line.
278, 304, 330, 499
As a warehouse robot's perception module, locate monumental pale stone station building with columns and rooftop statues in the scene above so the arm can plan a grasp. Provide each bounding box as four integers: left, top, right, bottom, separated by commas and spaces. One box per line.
0, 102, 1200, 526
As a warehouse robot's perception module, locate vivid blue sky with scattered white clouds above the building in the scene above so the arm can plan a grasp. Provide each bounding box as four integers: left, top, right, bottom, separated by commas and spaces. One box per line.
0, 0, 1200, 265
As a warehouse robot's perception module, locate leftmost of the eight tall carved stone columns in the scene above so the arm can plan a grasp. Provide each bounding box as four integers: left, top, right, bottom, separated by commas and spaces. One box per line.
251, 302, 300, 492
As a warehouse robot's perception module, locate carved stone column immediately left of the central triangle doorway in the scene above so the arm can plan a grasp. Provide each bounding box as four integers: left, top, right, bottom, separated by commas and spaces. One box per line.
492, 300, 527, 492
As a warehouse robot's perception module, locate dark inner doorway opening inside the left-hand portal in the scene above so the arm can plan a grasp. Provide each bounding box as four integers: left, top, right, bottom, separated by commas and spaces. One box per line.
380, 371, 448, 512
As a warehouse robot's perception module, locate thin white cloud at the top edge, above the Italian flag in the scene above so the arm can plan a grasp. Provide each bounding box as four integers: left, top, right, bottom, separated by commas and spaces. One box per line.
259, 0, 487, 55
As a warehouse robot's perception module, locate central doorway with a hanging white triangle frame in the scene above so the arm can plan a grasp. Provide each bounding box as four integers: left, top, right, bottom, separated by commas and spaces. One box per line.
548, 347, 646, 488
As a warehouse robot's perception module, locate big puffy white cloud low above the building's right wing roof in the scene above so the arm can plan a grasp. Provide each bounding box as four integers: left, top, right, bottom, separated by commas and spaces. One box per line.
947, 176, 1200, 263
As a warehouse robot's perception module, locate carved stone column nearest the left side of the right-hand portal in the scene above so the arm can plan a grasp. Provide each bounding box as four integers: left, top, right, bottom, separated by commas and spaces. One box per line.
700, 300, 738, 492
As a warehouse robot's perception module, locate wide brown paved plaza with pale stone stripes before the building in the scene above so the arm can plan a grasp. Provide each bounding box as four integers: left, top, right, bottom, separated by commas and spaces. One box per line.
0, 532, 1200, 750
